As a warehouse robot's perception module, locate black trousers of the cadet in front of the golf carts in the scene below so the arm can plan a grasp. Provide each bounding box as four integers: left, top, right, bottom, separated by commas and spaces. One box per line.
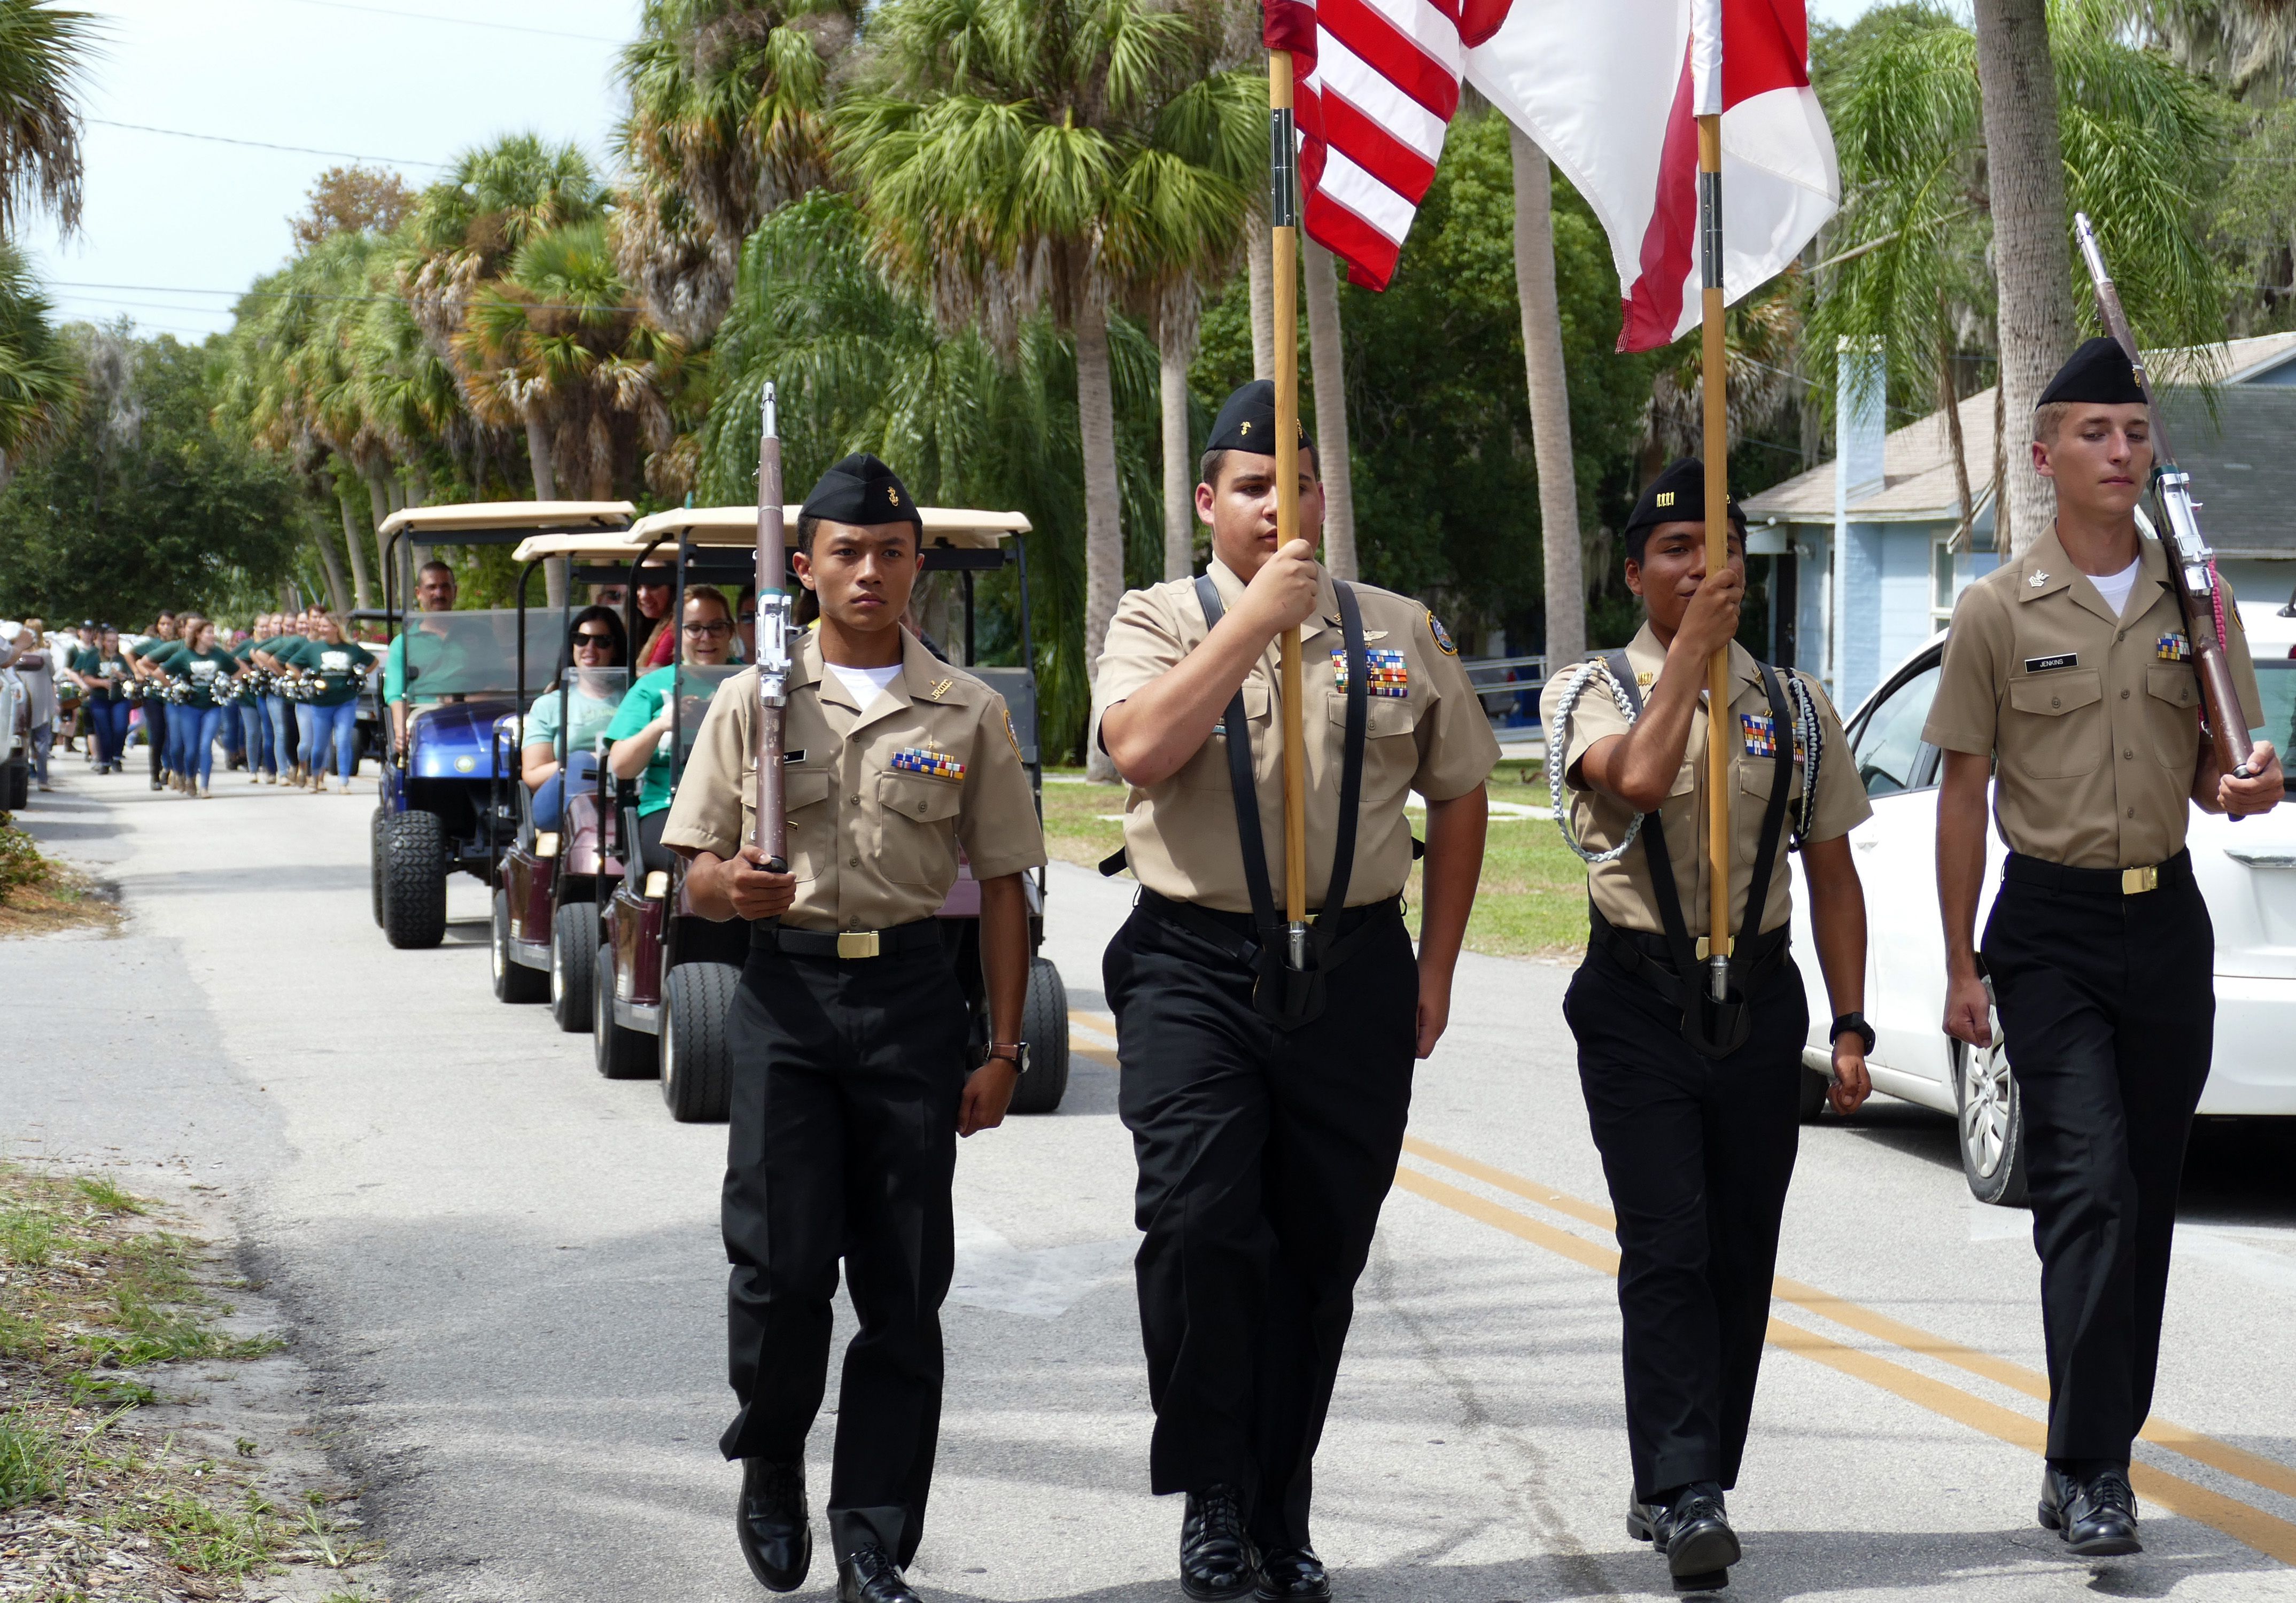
719, 932, 967, 1564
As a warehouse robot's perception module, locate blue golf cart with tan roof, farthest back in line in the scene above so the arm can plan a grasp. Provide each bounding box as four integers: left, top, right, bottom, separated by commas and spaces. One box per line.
372, 501, 636, 948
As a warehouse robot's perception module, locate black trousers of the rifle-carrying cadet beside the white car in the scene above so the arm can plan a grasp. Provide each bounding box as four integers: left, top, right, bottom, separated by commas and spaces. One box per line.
1984, 857, 2216, 1461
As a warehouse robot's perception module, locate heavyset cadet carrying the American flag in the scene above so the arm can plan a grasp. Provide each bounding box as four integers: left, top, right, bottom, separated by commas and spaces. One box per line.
1093, 381, 1499, 1598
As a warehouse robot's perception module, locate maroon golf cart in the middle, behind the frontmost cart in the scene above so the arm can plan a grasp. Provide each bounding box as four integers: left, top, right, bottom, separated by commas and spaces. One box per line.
491, 533, 636, 1033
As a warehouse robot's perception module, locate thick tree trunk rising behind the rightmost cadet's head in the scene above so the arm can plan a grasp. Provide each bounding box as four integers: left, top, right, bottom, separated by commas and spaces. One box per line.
1977, 0, 2078, 551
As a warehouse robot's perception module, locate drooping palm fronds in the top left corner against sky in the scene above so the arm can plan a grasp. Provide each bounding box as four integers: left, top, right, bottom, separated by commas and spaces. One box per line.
0, 0, 99, 237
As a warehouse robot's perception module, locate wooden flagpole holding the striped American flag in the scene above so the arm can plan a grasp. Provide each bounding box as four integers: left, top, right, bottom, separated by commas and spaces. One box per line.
1267, 51, 1306, 969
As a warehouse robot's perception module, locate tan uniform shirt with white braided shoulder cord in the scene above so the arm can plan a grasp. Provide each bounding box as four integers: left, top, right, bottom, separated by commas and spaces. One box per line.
1538, 625, 1874, 935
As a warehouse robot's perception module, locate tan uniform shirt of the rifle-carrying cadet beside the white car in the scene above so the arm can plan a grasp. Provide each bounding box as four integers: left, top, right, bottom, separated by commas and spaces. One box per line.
1922, 528, 2264, 868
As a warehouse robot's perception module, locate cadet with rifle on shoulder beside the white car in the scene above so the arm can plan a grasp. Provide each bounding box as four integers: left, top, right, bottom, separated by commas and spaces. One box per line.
1922, 340, 2282, 1557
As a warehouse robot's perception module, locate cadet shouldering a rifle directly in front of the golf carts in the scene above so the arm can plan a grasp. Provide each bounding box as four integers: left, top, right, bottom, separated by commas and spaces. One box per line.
661, 455, 1045, 1603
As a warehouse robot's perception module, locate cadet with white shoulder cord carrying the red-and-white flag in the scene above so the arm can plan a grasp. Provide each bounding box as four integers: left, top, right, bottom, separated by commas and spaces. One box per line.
1541, 460, 1874, 1592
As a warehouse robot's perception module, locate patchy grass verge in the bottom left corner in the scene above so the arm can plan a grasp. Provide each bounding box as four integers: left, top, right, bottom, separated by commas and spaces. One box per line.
0, 1164, 372, 1601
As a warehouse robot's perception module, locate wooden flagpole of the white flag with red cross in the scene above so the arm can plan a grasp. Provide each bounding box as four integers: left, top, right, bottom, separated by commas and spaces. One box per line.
1699, 112, 1726, 1001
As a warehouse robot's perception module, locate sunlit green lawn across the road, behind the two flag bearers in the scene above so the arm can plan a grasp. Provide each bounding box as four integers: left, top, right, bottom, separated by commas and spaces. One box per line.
1045, 758, 1587, 958
